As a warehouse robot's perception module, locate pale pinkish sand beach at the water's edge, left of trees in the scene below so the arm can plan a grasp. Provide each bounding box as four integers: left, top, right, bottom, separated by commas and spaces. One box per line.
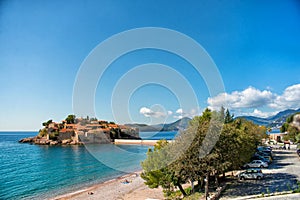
52, 172, 163, 200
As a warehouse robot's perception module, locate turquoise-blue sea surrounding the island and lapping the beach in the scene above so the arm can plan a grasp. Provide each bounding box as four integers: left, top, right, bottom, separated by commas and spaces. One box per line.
0, 132, 177, 200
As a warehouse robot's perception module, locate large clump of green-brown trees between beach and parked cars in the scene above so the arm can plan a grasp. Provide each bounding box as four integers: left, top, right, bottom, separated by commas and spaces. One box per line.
141, 108, 267, 198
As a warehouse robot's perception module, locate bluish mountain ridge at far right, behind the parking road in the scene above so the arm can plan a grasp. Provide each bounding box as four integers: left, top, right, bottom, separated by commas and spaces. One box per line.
237, 108, 300, 128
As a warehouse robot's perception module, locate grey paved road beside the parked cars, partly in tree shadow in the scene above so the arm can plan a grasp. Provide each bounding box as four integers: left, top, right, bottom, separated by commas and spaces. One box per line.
221, 150, 300, 200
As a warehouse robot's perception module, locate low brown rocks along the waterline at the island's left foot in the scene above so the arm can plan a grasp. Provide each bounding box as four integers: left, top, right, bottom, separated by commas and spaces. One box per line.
19, 136, 83, 145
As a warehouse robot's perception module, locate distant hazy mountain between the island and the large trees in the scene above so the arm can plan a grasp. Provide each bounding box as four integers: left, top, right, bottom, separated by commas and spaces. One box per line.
125, 117, 191, 132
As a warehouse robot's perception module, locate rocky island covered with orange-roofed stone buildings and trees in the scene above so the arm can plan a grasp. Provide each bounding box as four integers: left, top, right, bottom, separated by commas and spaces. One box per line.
19, 115, 141, 145
